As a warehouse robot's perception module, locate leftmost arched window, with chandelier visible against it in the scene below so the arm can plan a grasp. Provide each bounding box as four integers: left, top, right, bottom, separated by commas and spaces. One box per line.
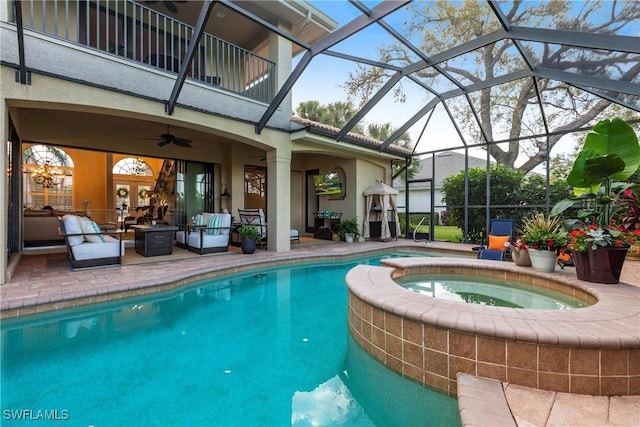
22, 144, 73, 210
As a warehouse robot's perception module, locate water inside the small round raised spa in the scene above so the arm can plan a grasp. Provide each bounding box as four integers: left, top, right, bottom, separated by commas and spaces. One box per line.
395, 274, 589, 310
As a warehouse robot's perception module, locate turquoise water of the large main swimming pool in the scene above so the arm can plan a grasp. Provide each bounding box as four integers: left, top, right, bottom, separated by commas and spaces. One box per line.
1, 257, 461, 426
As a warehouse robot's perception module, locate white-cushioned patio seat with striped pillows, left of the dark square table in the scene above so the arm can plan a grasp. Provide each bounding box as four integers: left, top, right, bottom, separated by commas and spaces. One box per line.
58, 215, 124, 269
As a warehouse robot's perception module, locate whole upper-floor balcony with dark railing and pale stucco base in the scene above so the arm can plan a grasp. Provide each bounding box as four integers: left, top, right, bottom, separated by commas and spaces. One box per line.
2, 0, 332, 124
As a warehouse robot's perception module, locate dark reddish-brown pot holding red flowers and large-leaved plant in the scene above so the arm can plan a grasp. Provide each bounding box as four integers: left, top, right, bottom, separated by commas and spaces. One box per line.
573, 247, 629, 284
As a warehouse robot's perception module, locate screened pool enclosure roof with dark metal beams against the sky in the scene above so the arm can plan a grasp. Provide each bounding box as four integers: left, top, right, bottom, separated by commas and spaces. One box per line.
256, 0, 640, 171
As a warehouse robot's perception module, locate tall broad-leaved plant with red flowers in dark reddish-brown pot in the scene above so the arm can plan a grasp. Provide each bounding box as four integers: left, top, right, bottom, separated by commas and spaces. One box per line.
551, 118, 640, 283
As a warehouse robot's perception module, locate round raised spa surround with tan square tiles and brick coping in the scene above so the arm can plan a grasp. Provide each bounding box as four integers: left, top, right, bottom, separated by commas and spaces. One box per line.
347, 258, 640, 396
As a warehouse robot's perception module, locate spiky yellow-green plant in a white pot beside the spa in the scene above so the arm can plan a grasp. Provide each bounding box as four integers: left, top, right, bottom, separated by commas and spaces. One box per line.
521, 213, 568, 272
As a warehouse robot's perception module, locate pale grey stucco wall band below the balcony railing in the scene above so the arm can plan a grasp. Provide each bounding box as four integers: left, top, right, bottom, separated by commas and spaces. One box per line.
0, 26, 291, 129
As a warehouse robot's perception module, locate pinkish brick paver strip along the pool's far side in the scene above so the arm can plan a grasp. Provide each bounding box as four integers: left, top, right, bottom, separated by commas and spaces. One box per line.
0, 240, 471, 320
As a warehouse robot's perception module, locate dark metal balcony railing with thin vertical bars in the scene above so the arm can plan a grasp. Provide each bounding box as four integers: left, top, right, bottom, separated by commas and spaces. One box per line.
13, 0, 275, 102
